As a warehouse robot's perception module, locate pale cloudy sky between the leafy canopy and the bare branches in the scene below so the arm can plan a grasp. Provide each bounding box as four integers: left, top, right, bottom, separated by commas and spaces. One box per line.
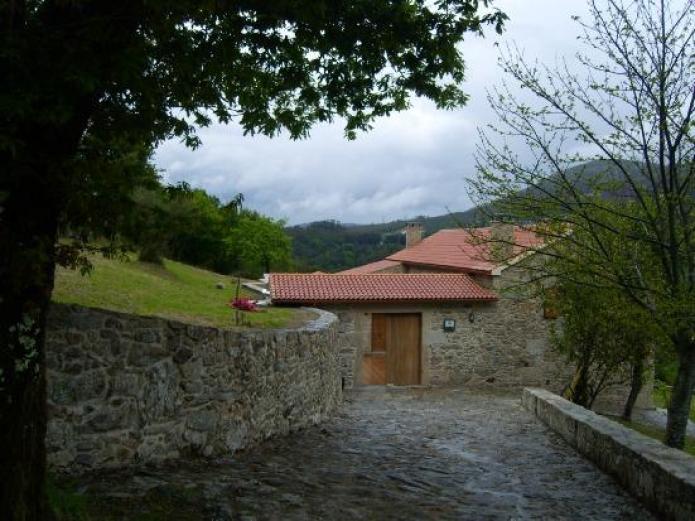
155, 0, 586, 224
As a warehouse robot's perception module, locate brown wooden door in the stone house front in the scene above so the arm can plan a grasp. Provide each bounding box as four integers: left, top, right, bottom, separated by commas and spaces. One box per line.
362, 313, 421, 385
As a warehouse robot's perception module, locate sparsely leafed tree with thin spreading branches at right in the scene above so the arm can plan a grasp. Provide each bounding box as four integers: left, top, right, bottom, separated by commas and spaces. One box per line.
473, 0, 695, 448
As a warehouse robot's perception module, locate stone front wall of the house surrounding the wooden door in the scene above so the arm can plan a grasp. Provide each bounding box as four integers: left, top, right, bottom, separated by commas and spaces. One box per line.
328, 300, 570, 390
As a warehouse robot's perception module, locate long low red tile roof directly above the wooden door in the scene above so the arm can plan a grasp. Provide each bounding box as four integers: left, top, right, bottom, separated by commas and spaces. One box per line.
269, 273, 497, 304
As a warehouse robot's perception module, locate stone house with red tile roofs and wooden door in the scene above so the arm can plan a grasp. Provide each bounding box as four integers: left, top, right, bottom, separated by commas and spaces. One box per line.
270, 223, 648, 408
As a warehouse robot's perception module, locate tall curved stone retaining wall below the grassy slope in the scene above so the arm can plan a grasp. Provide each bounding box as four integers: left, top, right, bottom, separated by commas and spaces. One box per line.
46, 305, 341, 472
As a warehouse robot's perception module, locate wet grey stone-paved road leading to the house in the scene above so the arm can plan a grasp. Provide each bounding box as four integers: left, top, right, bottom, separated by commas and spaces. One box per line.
88, 389, 653, 521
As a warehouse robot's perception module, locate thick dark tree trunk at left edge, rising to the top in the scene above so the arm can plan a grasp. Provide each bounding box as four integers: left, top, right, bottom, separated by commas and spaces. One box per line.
0, 0, 143, 521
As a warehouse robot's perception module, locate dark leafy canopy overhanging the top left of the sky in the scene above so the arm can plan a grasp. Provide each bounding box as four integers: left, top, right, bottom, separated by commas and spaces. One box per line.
0, 0, 506, 154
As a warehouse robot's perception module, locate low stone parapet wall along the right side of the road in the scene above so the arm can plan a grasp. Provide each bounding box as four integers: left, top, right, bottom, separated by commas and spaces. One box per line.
522, 389, 695, 521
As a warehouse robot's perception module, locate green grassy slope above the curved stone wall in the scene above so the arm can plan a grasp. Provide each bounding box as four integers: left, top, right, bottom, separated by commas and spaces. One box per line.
53, 256, 306, 327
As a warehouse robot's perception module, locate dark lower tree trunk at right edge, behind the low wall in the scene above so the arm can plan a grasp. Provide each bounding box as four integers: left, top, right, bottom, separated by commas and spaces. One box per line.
665, 340, 695, 449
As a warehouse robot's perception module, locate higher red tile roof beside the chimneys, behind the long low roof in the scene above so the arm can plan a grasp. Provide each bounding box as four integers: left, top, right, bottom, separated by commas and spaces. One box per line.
386, 226, 543, 274
